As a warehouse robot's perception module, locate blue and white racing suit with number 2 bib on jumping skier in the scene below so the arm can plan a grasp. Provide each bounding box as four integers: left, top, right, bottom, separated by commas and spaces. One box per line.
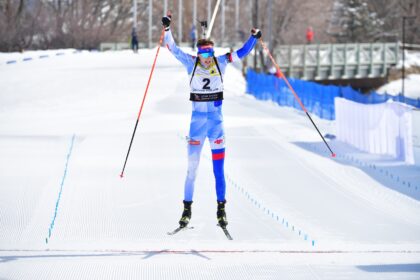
165, 30, 257, 201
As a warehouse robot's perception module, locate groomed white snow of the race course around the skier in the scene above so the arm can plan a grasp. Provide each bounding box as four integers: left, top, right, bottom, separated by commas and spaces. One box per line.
0, 49, 420, 279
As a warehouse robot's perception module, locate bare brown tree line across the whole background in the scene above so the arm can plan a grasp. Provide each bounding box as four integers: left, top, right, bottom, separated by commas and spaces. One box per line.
0, 0, 420, 52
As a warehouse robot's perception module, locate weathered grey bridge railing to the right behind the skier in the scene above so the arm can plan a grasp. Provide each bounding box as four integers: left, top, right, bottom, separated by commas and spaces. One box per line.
248, 43, 399, 80
